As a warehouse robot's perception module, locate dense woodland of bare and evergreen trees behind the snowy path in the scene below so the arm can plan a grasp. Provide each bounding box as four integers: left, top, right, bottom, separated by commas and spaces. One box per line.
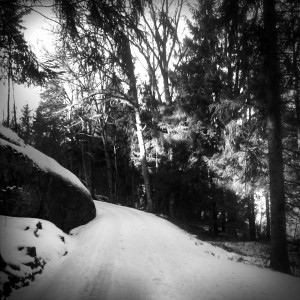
0, 0, 300, 272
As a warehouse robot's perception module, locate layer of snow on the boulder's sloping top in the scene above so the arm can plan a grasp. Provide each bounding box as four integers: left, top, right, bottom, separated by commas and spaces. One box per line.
0, 124, 89, 194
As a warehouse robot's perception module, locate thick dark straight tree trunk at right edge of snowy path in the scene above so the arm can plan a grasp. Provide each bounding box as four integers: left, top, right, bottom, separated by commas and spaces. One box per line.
263, 0, 290, 273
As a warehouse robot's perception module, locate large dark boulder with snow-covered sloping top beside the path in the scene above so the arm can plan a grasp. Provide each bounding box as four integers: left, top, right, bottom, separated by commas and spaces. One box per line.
0, 125, 96, 232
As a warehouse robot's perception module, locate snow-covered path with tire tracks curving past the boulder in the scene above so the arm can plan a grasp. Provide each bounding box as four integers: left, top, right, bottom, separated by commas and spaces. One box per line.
10, 202, 300, 300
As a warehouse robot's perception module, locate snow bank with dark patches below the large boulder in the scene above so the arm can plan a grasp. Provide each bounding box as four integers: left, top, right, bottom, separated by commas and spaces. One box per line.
0, 216, 73, 294
